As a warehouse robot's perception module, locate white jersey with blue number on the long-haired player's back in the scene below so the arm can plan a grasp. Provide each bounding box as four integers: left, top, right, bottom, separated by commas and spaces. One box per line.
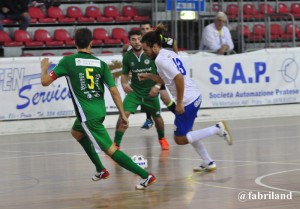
155, 49, 200, 106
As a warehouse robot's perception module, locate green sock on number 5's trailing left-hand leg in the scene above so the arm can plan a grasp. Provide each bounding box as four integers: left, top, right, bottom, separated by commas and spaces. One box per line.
78, 135, 104, 172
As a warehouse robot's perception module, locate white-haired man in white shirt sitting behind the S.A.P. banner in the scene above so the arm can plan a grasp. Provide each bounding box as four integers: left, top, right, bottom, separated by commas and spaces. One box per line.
200, 12, 234, 55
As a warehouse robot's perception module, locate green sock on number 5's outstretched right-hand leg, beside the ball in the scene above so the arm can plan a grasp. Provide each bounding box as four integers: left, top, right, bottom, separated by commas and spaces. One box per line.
111, 150, 149, 179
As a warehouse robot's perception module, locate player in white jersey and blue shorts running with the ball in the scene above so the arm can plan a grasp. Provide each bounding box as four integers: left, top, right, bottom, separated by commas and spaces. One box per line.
139, 31, 232, 171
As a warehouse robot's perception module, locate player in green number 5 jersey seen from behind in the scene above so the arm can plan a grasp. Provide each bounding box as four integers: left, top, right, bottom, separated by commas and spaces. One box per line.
41, 28, 156, 189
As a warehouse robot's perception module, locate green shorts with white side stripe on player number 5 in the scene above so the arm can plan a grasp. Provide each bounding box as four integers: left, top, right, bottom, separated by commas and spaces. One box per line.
72, 117, 112, 152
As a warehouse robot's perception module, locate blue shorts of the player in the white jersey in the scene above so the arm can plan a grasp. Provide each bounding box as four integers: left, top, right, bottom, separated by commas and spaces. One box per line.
174, 96, 201, 136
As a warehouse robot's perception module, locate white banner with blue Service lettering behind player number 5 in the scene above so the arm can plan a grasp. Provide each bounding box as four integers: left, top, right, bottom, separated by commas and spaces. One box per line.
0, 55, 124, 120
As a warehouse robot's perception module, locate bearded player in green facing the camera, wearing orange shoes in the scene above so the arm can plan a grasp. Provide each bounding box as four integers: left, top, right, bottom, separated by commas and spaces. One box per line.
114, 30, 169, 150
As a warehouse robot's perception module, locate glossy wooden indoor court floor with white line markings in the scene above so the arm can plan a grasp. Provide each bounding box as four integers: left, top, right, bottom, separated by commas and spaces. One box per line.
0, 116, 300, 209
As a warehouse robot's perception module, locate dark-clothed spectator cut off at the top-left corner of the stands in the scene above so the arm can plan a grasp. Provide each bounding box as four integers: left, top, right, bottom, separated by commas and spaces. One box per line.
0, 0, 30, 30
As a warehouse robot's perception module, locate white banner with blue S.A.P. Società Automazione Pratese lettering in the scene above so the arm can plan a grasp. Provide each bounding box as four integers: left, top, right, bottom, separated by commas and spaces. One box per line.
189, 48, 300, 107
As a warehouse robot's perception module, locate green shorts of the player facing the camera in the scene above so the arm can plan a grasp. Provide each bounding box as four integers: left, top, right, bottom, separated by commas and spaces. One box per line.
123, 92, 161, 117
